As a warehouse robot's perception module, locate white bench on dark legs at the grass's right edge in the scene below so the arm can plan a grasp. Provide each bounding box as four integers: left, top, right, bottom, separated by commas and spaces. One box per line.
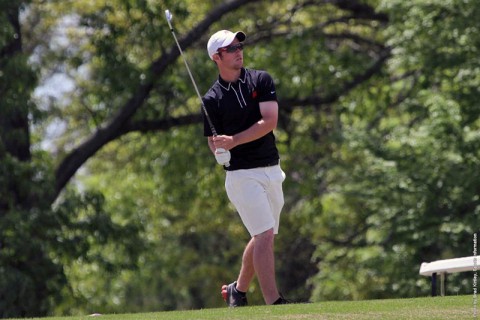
419, 256, 480, 296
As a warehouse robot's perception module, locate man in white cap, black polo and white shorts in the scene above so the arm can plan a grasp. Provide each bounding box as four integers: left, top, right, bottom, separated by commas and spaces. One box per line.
203, 30, 287, 307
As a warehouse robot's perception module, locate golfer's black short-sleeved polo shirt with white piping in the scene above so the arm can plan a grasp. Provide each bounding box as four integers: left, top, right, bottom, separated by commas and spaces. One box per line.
203, 68, 279, 170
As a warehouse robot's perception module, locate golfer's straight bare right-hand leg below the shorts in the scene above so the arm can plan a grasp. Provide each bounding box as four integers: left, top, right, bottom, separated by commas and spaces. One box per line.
250, 229, 280, 304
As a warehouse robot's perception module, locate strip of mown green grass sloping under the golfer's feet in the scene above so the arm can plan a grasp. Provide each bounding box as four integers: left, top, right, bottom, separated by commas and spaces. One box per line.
7, 296, 476, 320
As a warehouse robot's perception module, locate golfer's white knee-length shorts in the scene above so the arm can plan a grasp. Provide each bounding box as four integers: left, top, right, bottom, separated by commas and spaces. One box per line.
225, 165, 285, 237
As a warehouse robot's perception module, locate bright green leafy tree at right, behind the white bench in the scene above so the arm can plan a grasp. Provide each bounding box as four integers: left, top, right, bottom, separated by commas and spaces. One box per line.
306, 1, 480, 299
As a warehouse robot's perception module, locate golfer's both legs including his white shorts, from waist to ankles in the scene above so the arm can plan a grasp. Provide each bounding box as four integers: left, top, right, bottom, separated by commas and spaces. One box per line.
222, 166, 285, 306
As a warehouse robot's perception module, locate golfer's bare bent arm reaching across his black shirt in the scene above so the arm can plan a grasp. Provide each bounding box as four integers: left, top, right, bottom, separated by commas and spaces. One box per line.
213, 101, 278, 151
